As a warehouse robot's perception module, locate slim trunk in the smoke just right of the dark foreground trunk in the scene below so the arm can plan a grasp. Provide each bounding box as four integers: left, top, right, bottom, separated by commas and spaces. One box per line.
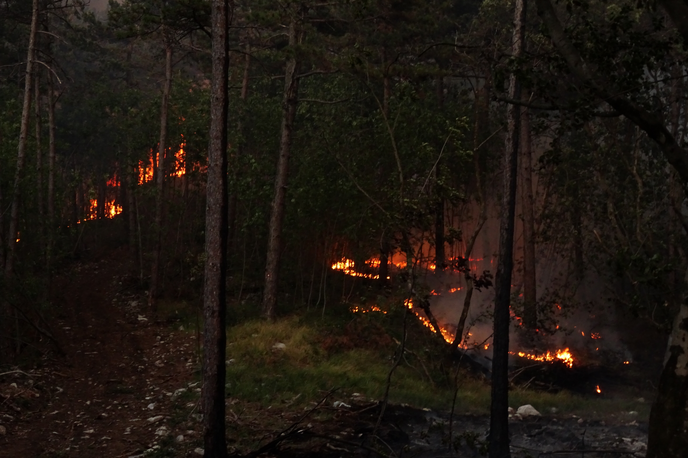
521, 109, 537, 330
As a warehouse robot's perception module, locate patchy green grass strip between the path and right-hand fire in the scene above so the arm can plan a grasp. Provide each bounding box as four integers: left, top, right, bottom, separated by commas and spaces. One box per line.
218, 314, 649, 420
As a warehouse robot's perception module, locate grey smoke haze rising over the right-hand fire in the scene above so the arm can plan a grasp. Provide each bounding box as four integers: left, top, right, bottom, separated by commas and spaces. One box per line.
425, 202, 632, 364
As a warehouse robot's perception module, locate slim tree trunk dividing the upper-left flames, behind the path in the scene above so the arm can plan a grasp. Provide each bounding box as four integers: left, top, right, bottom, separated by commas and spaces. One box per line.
148, 39, 172, 307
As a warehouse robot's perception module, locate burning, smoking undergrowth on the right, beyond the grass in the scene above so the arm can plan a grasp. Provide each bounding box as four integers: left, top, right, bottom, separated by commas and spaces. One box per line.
332, 250, 633, 394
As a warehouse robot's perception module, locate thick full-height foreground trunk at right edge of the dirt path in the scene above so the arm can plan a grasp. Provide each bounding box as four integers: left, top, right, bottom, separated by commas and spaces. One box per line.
201, 0, 229, 458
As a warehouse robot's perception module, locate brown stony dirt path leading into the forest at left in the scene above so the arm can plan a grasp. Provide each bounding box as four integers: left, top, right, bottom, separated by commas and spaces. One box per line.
0, 257, 200, 458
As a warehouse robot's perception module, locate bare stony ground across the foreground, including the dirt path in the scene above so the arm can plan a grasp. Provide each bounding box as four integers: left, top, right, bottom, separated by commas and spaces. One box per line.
0, 252, 647, 458
